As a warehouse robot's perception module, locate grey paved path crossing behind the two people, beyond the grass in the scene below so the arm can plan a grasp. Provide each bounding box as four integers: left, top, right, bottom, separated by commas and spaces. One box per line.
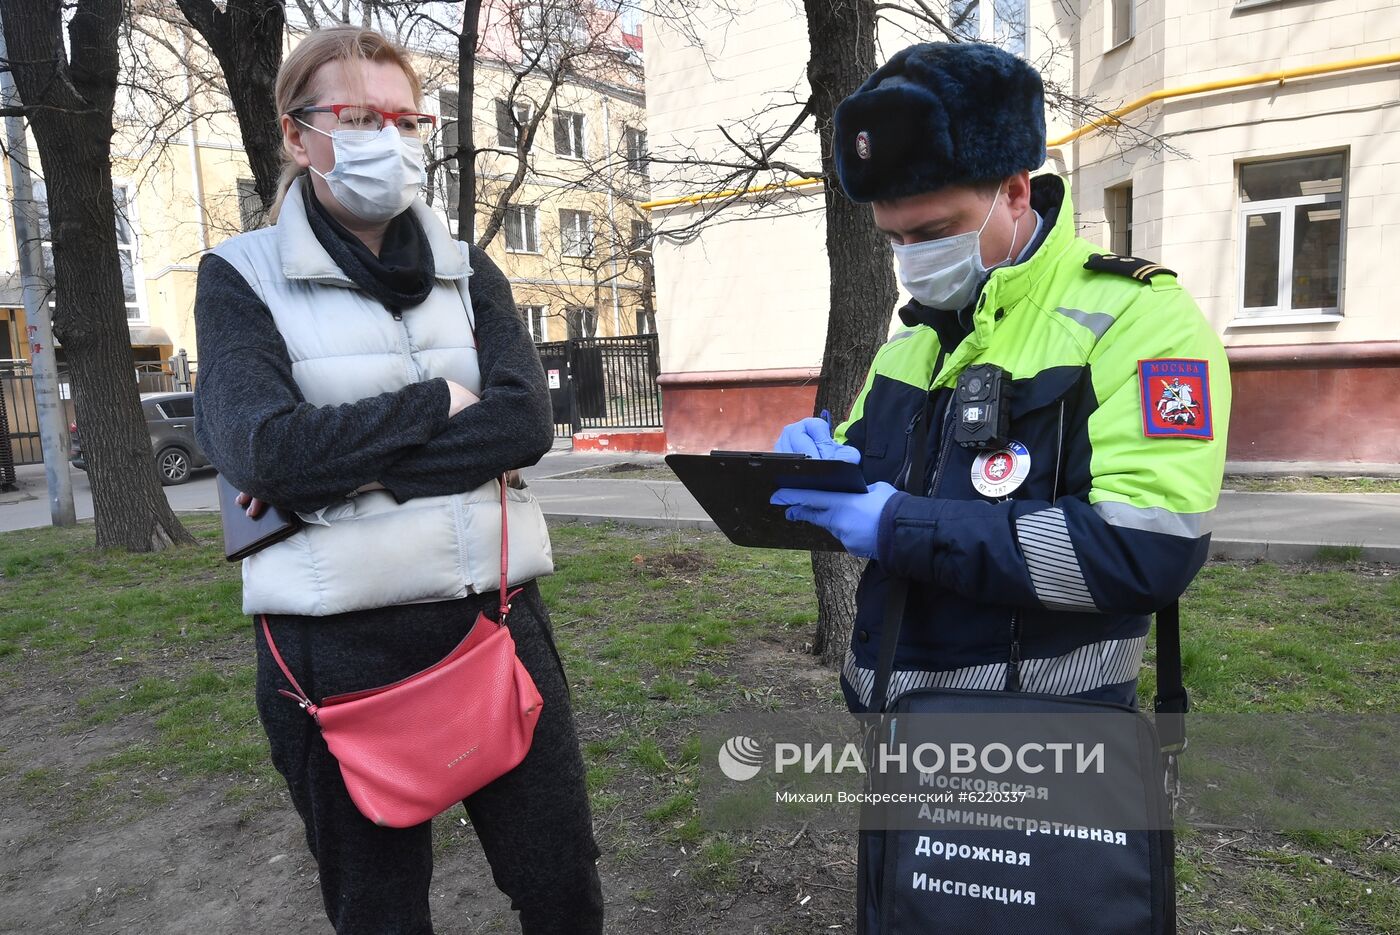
0, 449, 1400, 564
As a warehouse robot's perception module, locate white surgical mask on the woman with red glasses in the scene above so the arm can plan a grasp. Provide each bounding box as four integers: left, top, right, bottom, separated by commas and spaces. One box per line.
301, 120, 428, 224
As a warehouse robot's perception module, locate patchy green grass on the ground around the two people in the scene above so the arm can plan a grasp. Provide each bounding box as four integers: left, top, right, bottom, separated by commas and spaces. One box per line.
0, 515, 1400, 932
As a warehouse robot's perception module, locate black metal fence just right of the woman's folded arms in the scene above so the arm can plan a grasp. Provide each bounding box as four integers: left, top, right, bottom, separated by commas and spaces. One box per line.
535, 335, 661, 438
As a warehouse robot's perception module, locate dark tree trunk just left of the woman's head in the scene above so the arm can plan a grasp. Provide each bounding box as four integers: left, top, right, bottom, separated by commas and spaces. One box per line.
176, 0, 287, 216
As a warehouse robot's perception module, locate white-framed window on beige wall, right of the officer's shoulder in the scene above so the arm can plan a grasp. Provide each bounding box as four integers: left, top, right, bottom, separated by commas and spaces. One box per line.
1239, 153, 1347, 316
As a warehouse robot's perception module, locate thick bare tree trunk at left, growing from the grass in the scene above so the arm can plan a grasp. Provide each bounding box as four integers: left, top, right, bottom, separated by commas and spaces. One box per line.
0, 0, 195, 551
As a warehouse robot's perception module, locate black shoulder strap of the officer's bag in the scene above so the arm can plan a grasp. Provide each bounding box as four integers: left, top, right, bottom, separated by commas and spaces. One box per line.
869, 411, 1191, 754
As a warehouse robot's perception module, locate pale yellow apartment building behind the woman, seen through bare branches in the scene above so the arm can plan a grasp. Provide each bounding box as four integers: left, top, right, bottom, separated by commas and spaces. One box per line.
0, 9, 655, 380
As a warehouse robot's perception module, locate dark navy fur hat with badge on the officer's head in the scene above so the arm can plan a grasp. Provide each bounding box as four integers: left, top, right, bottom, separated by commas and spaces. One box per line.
833, 42, 1046, 202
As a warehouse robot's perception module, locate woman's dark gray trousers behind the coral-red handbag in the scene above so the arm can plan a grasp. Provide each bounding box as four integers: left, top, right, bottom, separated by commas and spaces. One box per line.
253, 582, 603, 935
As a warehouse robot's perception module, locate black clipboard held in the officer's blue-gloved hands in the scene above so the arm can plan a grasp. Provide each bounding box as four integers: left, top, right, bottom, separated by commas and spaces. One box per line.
666, 451, 865, 551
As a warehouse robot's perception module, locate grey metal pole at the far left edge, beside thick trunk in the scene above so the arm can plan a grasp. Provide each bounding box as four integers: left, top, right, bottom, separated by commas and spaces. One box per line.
0, 10, 77, 526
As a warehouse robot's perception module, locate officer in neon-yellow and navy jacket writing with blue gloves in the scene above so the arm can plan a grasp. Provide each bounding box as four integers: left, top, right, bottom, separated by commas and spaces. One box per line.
773, 43, 1229, 711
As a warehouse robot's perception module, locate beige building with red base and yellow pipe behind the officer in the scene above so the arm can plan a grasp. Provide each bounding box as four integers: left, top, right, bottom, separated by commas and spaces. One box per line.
647, 0, 1400, 462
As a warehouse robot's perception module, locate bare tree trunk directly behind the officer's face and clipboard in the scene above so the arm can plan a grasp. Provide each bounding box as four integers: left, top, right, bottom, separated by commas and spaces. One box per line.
805, 0, 897, 665
